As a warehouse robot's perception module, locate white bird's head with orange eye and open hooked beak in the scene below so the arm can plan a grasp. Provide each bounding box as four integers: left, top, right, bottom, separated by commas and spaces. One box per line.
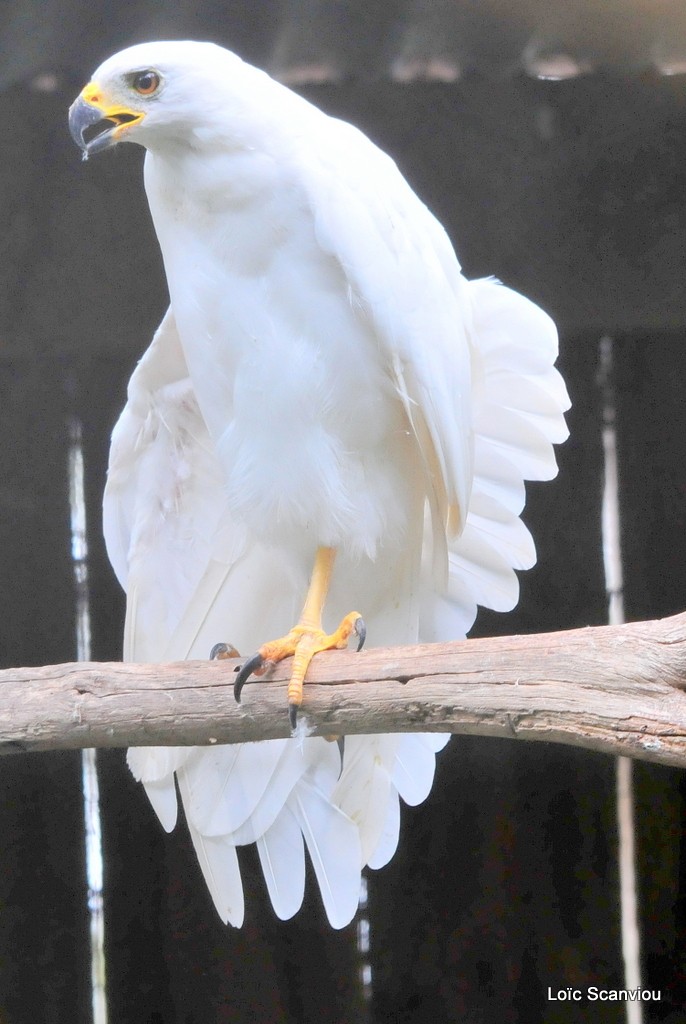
69, 42, 247, 160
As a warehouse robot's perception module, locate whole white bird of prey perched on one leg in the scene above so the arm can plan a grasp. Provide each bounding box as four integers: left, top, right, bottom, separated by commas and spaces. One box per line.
70, 42, 568, 928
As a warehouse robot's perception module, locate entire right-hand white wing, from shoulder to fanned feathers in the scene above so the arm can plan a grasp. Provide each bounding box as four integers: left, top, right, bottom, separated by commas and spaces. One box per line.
286, 112, 569, 622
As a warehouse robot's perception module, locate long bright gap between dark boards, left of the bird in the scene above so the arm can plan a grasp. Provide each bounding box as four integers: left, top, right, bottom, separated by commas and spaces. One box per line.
69, 417, 108, 1024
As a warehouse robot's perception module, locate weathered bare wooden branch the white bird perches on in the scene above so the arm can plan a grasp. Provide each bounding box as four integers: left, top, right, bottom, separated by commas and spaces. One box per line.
0, 613, 686, 766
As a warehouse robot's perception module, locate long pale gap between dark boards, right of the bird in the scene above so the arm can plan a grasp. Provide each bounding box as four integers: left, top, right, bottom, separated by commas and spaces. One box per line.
598, 337, 643, 1024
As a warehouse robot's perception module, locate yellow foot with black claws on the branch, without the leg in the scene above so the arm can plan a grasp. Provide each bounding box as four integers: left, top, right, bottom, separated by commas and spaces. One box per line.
233, 611, 367, 729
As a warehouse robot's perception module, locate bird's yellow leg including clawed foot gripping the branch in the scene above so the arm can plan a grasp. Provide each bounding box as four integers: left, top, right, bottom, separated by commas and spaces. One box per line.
233, 548, 367, 728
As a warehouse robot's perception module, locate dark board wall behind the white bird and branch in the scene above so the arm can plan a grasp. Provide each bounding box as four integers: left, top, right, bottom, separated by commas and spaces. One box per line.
0, 0, 686, 1024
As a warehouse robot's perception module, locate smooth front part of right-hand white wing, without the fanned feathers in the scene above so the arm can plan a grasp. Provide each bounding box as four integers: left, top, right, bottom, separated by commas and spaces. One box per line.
299, 118, 472, 526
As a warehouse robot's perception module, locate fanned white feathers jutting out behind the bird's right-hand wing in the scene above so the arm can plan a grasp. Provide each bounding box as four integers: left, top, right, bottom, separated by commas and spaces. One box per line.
420, 279, 569, 641
